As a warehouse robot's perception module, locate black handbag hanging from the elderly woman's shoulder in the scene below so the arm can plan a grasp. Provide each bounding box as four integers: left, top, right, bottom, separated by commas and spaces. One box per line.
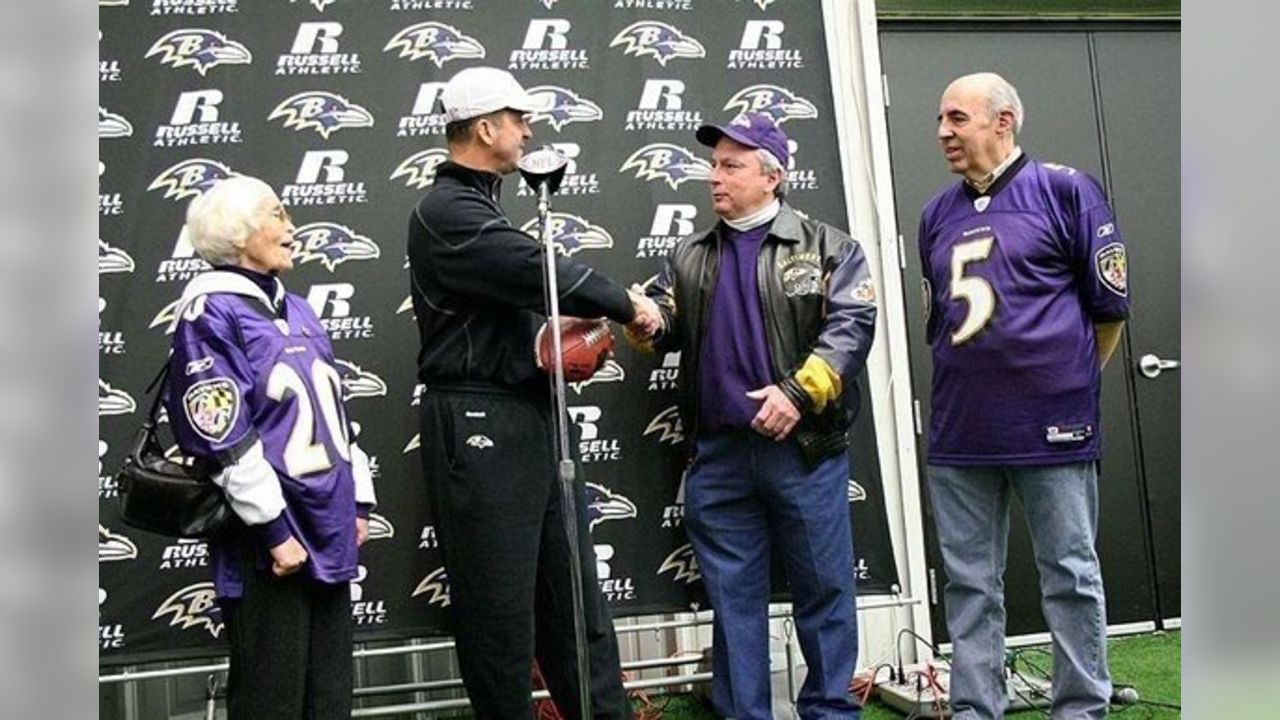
115, 361, 236, 538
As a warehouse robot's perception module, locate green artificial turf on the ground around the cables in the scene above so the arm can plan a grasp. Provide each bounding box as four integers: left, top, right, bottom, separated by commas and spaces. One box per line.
640, 633, 1183, 720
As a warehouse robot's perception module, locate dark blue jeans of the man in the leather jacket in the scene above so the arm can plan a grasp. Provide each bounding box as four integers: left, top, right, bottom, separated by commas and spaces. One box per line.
685, 430, 858, 720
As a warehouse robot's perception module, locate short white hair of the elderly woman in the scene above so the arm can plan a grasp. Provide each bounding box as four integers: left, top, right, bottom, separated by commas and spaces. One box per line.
183, 176, 275, 265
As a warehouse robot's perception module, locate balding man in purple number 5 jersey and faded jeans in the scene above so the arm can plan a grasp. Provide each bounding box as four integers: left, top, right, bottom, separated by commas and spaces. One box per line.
919, 73, 1129, 720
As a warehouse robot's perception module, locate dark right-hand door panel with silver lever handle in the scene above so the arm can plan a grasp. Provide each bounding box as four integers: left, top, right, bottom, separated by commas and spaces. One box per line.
1093, 32, 1183, 620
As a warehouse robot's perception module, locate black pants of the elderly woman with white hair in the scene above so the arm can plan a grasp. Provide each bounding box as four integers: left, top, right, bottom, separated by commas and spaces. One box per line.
223, 568, 352, 720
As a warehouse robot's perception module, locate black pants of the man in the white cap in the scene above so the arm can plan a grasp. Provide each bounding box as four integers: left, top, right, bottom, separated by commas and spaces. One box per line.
421, 388, 630, 720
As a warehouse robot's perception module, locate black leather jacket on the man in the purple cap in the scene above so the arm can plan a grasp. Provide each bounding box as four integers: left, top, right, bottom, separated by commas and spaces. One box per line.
648, 202, 876, 462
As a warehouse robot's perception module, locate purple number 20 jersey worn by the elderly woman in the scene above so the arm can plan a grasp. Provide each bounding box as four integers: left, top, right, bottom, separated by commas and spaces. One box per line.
166, 272, 357, 597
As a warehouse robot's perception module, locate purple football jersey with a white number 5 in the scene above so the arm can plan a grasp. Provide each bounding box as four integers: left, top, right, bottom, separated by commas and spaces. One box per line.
919, 156, 1129, 465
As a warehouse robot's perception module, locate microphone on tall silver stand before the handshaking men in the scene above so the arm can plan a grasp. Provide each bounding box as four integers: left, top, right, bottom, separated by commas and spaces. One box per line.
520, 147, 591, 719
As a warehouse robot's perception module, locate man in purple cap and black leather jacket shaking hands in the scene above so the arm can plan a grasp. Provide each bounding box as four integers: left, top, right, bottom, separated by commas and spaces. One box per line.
628, 113, 876, 719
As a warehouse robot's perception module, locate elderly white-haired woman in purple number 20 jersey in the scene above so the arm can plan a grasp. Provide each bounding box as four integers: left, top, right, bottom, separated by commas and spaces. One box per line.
166, 177, 374, 719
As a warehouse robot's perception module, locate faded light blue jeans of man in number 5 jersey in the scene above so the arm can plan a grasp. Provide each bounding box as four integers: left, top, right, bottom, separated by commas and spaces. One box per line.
929, 462, 1111, 720
